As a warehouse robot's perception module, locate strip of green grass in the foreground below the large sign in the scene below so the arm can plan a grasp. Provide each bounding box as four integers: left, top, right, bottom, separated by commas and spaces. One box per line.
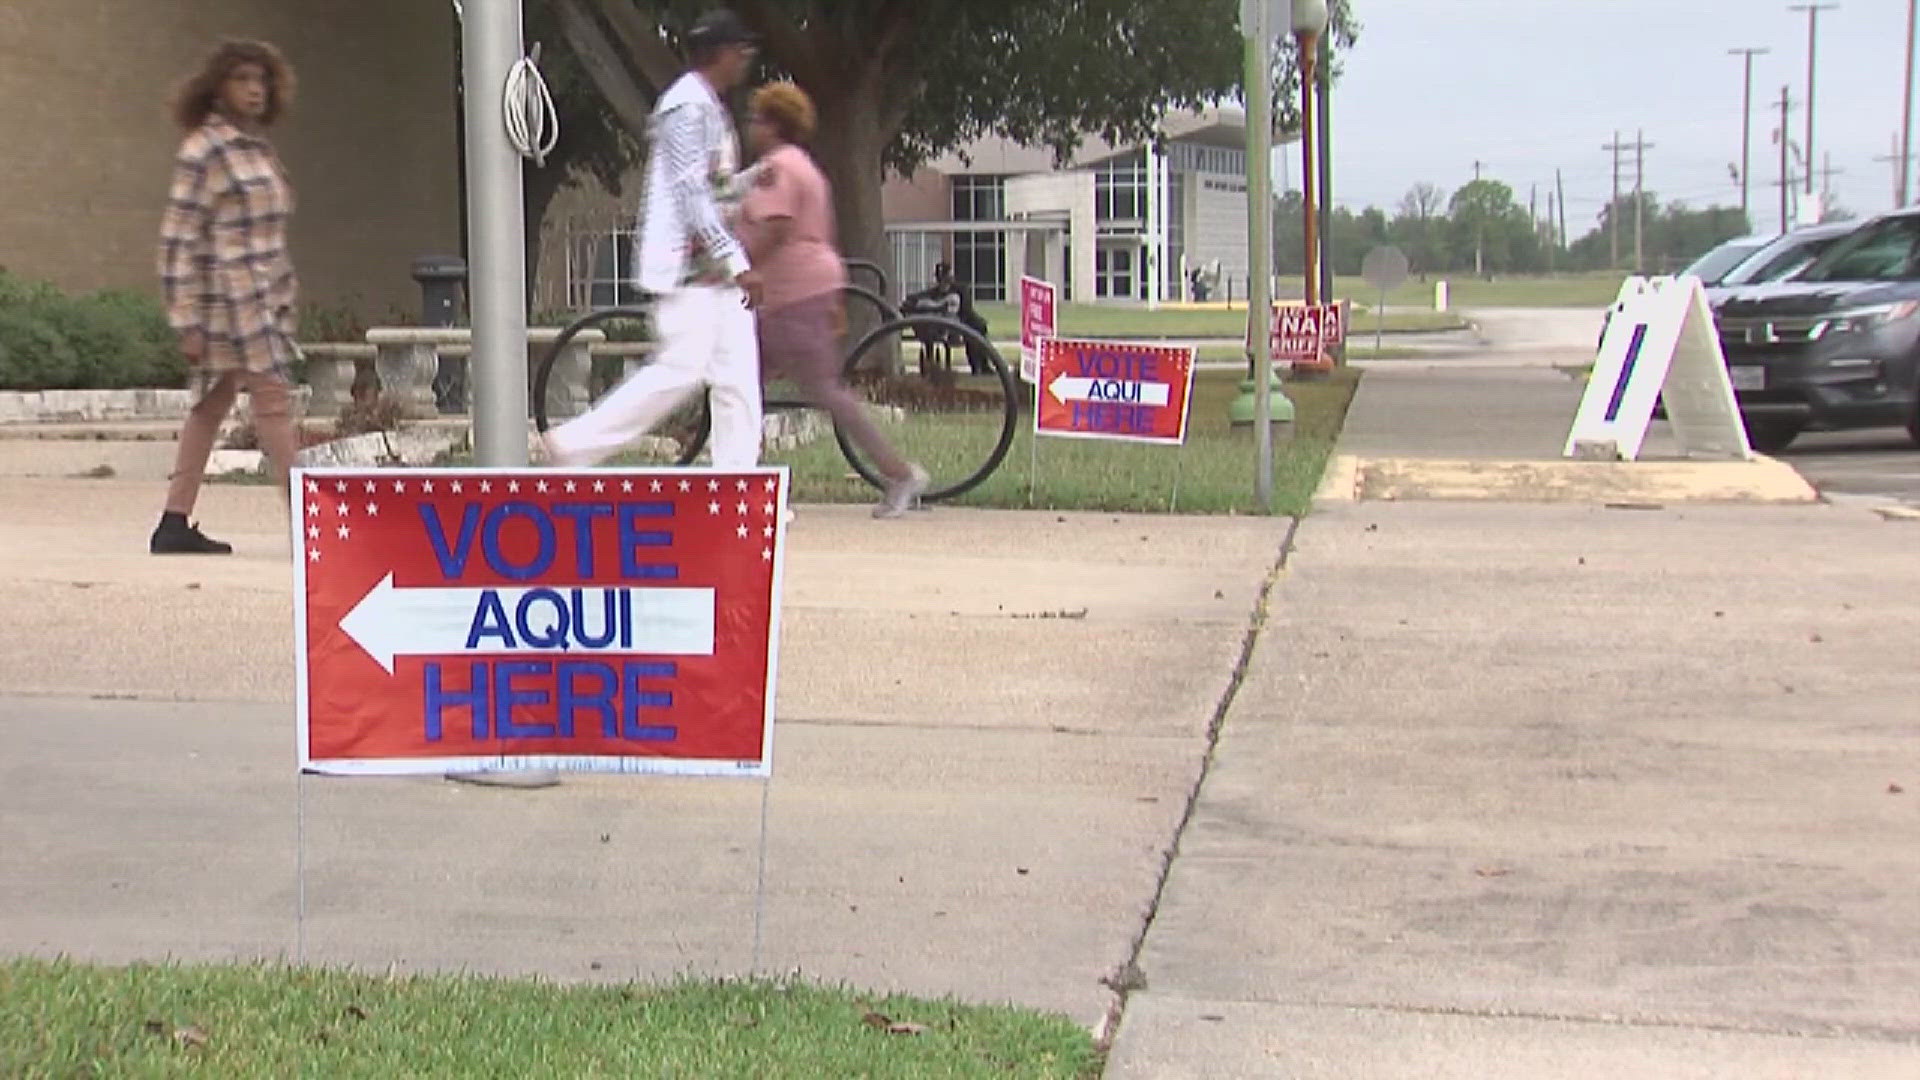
0, 959, 1100, 1080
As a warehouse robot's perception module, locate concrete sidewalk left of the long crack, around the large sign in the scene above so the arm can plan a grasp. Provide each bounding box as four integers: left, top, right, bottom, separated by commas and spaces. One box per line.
0, 470, 1290, 1030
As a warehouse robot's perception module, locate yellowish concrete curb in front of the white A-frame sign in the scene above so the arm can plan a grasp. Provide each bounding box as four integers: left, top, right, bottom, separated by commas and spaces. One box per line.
1354, 457, 1820, 503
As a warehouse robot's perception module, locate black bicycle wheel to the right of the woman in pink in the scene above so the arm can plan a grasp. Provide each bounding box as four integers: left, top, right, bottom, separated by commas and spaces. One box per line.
833, 315, 1020, 502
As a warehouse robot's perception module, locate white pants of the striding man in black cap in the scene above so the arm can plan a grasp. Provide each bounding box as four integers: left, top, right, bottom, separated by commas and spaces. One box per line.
547, 286, 760, 469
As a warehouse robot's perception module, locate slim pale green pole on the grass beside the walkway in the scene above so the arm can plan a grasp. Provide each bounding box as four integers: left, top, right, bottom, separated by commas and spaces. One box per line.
1240, 0, 1273, 513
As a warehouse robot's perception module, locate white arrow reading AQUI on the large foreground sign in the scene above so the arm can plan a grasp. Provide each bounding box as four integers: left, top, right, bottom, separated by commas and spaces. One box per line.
340, 575, 714, 675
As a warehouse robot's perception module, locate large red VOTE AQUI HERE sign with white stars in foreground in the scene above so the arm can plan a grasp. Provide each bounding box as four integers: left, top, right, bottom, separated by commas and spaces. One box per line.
292, 469, 787, 776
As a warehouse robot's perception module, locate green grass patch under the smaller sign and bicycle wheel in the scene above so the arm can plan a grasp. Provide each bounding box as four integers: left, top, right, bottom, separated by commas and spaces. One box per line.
768, 371, 1359, 515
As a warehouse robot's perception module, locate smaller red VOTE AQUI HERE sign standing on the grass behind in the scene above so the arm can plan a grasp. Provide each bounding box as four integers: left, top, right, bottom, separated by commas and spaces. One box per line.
1033, 338, 1194, 444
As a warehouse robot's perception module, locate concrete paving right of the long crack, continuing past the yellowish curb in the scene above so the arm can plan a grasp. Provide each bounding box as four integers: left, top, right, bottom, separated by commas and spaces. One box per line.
1108, 359, 1920, 1080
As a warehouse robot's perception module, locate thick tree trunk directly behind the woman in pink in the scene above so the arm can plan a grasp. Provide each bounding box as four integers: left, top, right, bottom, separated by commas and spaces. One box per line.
808, 75, 900, 375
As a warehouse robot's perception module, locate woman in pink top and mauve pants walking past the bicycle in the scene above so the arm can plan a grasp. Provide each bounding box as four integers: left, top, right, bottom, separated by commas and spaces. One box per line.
741, 83, 927, 517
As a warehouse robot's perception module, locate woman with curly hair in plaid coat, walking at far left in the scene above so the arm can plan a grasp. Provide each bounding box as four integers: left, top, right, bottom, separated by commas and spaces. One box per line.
150, 42, 298, 555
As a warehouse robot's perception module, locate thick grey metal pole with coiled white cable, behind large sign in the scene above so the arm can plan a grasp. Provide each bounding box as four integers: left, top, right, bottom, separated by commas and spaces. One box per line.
461, 0, 528, 467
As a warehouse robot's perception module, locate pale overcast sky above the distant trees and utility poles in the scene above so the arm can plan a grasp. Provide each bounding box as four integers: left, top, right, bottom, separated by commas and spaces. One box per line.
1288, 0, 1920, 238
